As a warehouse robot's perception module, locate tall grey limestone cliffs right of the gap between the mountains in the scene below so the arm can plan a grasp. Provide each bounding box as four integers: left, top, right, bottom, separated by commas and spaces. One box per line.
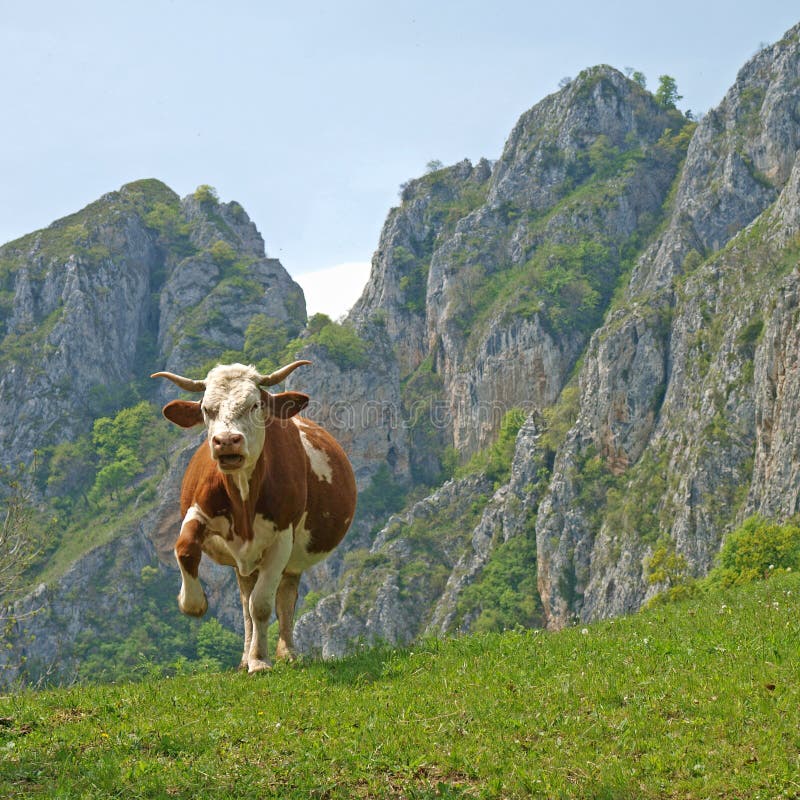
298, 23, 800, 652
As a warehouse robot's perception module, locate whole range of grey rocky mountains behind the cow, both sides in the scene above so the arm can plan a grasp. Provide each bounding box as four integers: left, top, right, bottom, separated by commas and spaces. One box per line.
0, 20, 800, 680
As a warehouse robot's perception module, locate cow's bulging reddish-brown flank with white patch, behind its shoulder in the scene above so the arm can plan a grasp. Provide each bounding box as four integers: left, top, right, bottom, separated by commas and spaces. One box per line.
293, 417, 356, 553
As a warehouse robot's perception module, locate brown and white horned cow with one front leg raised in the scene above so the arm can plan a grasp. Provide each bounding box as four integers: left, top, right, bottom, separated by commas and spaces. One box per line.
152, 361, 356, 672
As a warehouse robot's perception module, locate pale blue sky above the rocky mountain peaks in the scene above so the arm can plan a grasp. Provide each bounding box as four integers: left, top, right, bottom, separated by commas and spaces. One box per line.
0, 0, 800, 314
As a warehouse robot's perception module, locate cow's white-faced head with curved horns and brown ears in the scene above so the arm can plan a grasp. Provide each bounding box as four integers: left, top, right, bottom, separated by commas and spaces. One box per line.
150, 361, 311, 473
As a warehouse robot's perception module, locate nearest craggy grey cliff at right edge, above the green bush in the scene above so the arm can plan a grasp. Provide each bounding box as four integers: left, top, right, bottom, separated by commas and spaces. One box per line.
537, 21, 800, 627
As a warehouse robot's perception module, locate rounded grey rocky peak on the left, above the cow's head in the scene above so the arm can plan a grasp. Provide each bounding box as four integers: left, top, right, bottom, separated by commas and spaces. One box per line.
0, 181, 305, 464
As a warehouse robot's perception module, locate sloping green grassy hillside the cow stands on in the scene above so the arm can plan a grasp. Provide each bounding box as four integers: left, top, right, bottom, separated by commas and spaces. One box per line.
0, 574, 800, 798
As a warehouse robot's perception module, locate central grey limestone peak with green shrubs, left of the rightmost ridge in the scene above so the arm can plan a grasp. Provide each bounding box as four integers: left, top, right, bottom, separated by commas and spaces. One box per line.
350, 67, 685, 482
